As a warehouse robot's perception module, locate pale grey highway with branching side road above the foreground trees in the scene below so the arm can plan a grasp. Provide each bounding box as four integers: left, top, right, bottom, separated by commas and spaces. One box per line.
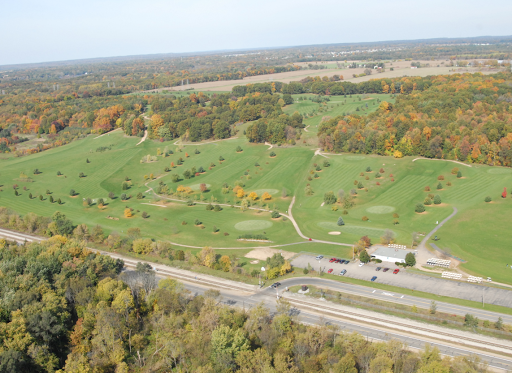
0, 229, 512, 371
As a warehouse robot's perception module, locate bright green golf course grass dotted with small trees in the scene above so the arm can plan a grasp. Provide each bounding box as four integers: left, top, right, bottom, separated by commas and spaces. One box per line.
0, 126, 512, 283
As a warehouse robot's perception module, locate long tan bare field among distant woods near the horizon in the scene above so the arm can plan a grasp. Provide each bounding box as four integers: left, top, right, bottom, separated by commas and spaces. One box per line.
145, 60, 499, 92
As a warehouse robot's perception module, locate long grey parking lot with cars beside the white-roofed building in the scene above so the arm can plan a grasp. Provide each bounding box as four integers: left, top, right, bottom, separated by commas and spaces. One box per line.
291, 254, 512, 307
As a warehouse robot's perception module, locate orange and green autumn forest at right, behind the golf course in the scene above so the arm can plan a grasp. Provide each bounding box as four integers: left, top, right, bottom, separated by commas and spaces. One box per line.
318, 73, 512, 166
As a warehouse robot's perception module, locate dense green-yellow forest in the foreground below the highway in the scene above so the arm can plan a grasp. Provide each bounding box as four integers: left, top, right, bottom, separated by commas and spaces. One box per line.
0, 235, 486, 373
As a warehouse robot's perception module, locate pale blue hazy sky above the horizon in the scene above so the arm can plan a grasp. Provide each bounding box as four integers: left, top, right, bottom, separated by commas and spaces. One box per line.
0, 0, 512, 65
